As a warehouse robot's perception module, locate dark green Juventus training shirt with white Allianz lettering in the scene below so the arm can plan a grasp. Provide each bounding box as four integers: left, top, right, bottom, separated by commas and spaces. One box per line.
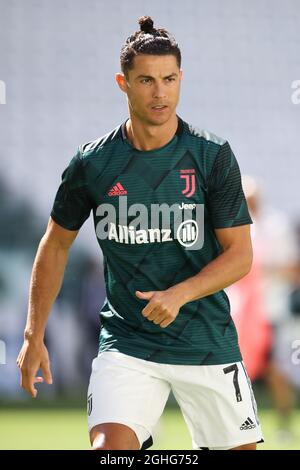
51, 118, 252, 365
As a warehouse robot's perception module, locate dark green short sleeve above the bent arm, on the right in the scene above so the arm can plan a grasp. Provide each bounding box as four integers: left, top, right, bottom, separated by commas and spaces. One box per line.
207, 142, 252, 228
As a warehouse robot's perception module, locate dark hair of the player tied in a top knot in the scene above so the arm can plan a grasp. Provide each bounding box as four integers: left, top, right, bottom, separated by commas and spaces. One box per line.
120, 16, 181, 75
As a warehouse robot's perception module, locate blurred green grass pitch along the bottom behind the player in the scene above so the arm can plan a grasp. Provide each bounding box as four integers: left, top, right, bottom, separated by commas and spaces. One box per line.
0, 408, 300, 450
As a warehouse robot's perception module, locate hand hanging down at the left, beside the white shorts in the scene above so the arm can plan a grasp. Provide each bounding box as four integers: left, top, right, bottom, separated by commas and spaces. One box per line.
17, 339, 52, 398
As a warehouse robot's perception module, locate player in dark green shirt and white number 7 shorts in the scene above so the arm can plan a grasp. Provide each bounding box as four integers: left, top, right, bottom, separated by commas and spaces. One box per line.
17, 13, 262, 450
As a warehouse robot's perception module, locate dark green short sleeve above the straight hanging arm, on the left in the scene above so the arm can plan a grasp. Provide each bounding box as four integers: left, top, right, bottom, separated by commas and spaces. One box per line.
51, 150, 92, 230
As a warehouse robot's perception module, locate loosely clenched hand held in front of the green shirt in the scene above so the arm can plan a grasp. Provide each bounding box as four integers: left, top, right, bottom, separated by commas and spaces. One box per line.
135, 288, 185, 328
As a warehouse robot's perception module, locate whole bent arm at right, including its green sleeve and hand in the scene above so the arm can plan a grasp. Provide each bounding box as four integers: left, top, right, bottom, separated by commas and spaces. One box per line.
136, 142, 252, 328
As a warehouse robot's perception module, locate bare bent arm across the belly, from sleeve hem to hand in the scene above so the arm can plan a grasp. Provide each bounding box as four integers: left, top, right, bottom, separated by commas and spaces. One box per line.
136, 225, 252, 328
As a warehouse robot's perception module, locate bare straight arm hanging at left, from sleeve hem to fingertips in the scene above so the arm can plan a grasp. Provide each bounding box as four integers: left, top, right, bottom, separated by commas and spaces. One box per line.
17, 218, 78, 398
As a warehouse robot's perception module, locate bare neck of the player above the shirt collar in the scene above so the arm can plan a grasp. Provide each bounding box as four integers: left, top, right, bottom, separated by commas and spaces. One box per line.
126, 114, 178, 151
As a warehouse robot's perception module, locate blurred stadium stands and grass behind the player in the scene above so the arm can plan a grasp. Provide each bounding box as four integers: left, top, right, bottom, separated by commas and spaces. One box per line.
0, 0, 300, 449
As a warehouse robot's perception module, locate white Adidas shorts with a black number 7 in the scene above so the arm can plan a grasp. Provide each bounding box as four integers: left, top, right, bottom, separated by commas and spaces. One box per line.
88, 351, 263, 450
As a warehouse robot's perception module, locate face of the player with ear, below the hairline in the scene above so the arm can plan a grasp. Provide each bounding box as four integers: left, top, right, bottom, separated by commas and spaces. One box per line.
116, 54, 182, 126
